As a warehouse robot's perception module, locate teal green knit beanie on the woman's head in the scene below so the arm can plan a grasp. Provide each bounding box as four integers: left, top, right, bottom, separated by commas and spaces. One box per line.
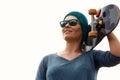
64, 11, 90, 44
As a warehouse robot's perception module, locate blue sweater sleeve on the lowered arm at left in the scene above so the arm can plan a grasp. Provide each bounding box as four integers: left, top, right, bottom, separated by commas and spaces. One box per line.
36, 57, 47, 80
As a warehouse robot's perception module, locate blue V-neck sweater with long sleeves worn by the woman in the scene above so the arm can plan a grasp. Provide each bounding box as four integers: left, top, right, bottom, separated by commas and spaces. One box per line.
36, 50, 120, 80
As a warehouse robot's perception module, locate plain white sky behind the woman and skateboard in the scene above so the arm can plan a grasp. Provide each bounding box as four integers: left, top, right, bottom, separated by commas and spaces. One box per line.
0, 0, 120, 80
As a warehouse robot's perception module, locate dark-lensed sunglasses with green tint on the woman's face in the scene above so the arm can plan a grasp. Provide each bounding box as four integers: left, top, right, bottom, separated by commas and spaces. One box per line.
60, 19, 79, 28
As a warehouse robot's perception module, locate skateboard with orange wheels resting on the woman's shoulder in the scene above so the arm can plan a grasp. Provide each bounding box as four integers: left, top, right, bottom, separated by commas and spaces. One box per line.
85, 4, 120, 51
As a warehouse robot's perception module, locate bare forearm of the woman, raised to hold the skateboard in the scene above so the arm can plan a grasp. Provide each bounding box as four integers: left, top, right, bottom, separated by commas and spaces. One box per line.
107, 32, 120, 57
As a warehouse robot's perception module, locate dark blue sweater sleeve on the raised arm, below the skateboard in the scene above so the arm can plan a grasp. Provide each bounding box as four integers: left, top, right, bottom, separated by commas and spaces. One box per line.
94, 51, 120, 68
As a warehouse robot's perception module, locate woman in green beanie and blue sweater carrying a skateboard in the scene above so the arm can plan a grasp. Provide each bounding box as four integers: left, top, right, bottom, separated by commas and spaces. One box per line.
36, 11, 120, 80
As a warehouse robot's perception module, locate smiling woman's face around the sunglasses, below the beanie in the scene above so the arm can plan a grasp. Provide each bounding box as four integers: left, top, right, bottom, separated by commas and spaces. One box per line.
62, 16, 82, 41
